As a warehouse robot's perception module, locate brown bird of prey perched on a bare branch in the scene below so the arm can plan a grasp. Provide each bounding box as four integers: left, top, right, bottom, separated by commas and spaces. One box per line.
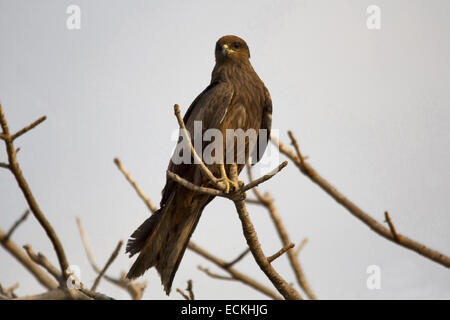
126, 35, 272, 294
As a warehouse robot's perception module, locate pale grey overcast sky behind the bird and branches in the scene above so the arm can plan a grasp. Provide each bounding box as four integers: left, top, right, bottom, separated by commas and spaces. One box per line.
0, 0, 450, 299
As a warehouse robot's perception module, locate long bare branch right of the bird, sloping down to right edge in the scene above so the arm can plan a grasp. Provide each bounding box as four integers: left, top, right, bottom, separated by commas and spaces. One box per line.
272, 133, 450, 268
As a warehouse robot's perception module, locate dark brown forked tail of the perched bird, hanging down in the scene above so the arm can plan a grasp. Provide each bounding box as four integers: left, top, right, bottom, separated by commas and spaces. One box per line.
126, 191, 209, 295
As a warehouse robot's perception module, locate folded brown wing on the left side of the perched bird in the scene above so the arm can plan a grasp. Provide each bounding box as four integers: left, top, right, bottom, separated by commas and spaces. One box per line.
160, 82, 234, 207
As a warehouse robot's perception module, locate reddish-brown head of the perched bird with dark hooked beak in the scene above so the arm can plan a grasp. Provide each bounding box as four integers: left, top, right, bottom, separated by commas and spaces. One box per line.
216, 36, 250, 62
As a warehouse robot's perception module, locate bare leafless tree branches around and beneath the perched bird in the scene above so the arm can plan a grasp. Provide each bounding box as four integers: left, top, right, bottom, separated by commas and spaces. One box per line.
0, 105, 450, 300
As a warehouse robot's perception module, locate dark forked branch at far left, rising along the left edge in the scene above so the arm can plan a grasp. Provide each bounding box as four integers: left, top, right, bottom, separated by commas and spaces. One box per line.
0, 104, 69, 280
